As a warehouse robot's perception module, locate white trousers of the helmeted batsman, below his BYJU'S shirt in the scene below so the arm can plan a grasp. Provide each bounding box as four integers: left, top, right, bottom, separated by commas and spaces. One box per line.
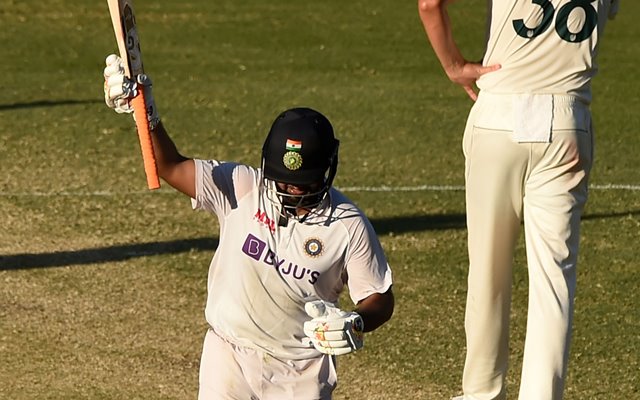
198, 329, 337, 400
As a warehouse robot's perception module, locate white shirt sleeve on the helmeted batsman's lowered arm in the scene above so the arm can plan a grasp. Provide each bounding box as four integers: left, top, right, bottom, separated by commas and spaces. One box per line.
346, 215, 392, 304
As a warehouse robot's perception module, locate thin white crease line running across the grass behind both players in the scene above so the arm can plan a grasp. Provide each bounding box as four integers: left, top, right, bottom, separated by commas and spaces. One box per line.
0, 183, 640, 197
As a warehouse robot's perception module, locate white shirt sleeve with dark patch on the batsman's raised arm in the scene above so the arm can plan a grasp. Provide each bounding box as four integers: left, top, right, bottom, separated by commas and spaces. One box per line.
191, 160, 259, 217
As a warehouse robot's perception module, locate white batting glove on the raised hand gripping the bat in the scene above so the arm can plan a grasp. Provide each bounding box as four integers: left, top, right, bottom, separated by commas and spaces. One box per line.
104, 54, 160, 130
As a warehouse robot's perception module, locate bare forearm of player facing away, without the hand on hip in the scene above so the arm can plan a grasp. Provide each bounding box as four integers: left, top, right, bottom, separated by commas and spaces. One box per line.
418, 0, 466, 81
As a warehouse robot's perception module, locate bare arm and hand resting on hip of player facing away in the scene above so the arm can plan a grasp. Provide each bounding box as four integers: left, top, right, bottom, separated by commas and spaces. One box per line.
418, 0, 500, 101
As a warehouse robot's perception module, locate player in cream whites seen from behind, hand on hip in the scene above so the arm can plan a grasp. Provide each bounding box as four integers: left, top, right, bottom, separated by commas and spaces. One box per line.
418, 0, 618, 400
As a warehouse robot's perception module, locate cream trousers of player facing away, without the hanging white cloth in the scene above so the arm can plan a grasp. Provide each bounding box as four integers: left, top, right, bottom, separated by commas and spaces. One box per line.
463, 92, 593, 400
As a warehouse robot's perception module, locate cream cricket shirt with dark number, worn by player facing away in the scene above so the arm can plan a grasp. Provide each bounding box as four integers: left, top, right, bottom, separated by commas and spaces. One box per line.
477, 0, 618, 103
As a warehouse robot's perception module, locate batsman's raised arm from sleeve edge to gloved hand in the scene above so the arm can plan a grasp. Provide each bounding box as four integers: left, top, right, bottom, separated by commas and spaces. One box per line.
104, 54, 195, 197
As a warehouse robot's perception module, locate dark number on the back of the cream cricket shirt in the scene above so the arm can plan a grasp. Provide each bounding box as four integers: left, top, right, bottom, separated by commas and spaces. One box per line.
513, 0, 598, 43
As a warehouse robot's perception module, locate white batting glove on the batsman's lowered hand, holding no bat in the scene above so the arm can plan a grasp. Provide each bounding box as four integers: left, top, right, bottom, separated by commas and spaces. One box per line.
304, 300, 364, 355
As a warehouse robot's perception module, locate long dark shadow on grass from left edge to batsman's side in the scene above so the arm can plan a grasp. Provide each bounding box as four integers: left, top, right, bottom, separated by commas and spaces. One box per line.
0, 237, 218, 271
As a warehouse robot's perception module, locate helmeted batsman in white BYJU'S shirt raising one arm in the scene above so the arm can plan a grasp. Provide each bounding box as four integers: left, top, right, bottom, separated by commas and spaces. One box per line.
104, 55, 394, 400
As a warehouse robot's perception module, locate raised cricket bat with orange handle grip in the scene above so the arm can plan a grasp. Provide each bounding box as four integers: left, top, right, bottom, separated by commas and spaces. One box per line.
107, 0, 160, 189
